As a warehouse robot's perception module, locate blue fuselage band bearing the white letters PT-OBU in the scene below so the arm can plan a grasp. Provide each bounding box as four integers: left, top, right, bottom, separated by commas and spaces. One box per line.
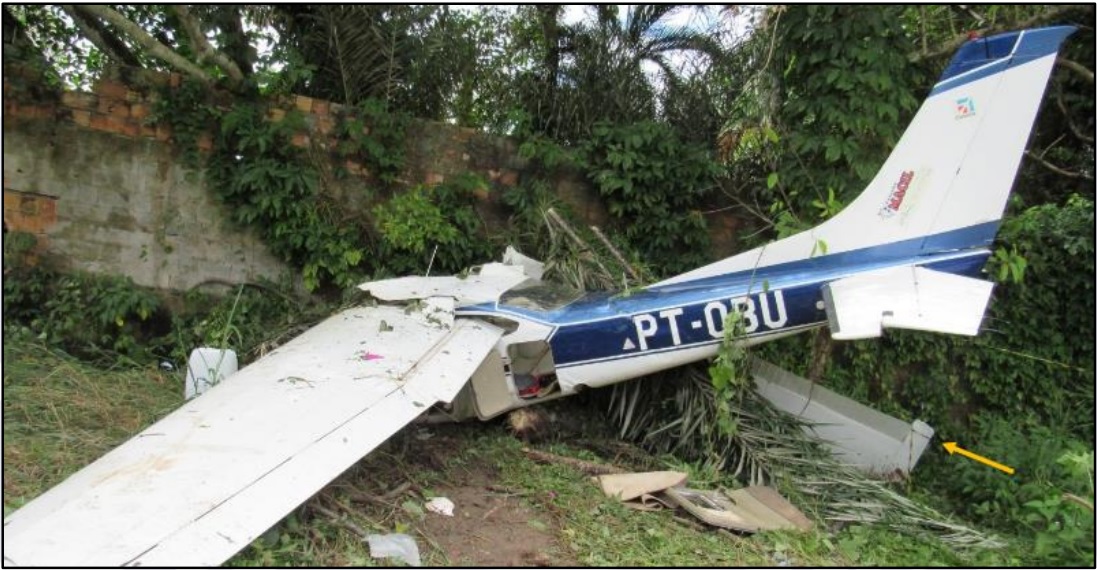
457, 224, 996, 368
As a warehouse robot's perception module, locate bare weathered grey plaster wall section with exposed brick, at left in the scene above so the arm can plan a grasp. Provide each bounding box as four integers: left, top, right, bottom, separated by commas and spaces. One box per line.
3, 121, 285, 289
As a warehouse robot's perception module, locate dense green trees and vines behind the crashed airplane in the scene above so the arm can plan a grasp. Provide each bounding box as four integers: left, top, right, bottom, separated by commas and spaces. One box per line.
3, 4, 1097, 563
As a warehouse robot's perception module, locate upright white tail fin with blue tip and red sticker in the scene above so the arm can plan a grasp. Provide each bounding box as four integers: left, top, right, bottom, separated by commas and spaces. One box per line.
653, 26, 1074, 287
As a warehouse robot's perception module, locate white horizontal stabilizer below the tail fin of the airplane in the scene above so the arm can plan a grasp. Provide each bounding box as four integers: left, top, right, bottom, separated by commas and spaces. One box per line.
823, 266, 994, 340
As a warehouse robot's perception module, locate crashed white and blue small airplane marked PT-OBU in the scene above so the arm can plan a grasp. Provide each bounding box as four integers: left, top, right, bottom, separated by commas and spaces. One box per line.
3, 26, 1074, 566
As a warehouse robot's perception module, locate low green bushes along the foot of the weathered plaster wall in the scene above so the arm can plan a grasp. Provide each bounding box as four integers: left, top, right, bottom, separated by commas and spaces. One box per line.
3, 256, 307, 365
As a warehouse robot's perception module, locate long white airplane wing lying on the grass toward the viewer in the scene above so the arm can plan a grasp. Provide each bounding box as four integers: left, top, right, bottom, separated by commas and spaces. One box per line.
3, 298, 502, 567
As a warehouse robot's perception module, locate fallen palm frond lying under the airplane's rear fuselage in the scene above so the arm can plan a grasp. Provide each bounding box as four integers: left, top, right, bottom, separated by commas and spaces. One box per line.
610, 366, 1004, 548
